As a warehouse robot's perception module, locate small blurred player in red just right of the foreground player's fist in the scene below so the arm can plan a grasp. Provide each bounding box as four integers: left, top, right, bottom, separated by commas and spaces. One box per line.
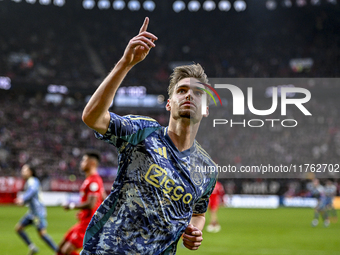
207, 182, 224, 233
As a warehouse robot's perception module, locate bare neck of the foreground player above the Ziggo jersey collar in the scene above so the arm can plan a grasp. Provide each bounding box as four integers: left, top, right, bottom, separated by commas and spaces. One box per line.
168, 119, 199, 151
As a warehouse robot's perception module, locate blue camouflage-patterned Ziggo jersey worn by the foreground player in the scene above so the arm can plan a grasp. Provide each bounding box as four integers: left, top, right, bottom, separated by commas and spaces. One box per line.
81, 113, 216, 255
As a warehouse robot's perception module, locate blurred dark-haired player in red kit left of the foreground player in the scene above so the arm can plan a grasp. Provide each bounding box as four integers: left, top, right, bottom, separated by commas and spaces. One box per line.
57, 152, 106, 255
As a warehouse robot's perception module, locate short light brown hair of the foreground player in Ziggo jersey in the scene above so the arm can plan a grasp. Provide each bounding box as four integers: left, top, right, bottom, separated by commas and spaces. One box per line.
168, 64, 208, 98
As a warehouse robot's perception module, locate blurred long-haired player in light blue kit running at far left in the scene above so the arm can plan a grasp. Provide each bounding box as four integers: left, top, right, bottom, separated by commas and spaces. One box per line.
14, 164, 58, 254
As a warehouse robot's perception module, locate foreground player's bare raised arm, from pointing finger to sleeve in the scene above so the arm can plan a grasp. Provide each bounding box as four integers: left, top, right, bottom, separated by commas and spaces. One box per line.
82, 17, 158, 135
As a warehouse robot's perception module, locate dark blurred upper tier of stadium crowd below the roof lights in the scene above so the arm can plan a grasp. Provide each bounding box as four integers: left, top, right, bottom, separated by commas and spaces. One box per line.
0, 4, 340, 89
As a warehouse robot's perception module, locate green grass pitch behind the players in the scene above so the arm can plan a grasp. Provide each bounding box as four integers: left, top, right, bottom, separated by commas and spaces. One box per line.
0, 206, 340, 255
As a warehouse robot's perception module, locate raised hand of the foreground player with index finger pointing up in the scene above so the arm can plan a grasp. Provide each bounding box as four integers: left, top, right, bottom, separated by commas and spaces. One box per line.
122, 17, 158, 67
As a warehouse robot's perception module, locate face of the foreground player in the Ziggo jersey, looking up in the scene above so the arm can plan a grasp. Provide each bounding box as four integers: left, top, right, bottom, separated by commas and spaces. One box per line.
166, 78, 208, 123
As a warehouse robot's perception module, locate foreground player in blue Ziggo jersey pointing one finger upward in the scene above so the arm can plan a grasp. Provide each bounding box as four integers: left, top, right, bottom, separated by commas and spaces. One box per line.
81, 18, 216, 255
